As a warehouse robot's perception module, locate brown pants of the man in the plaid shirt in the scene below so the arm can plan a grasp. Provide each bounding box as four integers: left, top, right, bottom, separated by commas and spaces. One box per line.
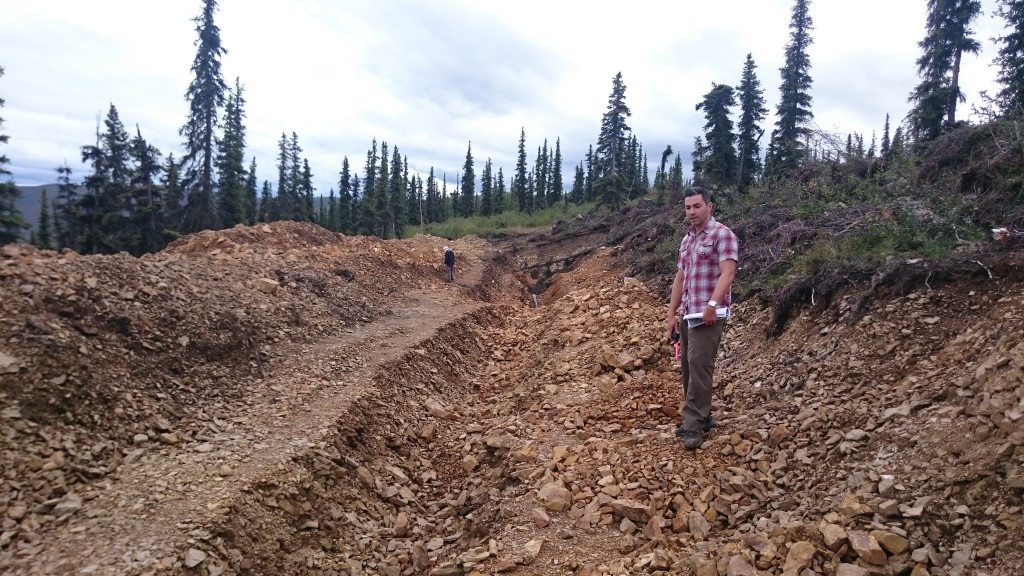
679, 319, 725, 431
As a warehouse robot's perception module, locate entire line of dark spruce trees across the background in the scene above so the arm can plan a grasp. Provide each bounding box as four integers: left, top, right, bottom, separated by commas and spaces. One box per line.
0, 0, 1024, 249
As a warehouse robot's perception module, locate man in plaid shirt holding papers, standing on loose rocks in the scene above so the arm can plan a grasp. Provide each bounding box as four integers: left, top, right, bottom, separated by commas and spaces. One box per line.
666, 187, 739, 450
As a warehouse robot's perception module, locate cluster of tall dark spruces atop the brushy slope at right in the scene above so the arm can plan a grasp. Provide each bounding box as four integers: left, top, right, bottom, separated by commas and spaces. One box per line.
688, 0, 1024, 191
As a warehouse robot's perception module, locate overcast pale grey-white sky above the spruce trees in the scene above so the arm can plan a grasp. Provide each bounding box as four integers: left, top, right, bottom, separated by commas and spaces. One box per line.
0, 0, 1004, 195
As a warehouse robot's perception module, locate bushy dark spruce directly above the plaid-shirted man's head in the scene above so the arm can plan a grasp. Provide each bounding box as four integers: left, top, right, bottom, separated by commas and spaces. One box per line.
696, 82, 737, 189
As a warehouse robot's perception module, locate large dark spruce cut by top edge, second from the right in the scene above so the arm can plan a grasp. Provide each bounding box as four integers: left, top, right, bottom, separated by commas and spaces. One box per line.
907, 0, 981, 143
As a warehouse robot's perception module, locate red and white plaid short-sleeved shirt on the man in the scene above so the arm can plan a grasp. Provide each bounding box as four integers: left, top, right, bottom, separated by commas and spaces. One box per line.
676, 218, 739, 315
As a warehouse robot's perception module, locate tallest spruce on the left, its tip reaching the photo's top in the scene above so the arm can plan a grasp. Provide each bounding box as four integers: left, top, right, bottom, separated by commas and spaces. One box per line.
178, 0, 227, 233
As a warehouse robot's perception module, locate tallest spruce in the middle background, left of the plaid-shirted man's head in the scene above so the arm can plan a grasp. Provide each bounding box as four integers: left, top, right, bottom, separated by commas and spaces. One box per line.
594, 72, 632, 209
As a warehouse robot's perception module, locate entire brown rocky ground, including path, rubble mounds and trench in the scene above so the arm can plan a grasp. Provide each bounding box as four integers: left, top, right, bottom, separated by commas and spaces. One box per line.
0, 217, 1024, 576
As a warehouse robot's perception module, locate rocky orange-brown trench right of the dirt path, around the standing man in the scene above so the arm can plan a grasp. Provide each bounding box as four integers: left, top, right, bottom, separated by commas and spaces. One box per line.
188, 245, 1024, 576
